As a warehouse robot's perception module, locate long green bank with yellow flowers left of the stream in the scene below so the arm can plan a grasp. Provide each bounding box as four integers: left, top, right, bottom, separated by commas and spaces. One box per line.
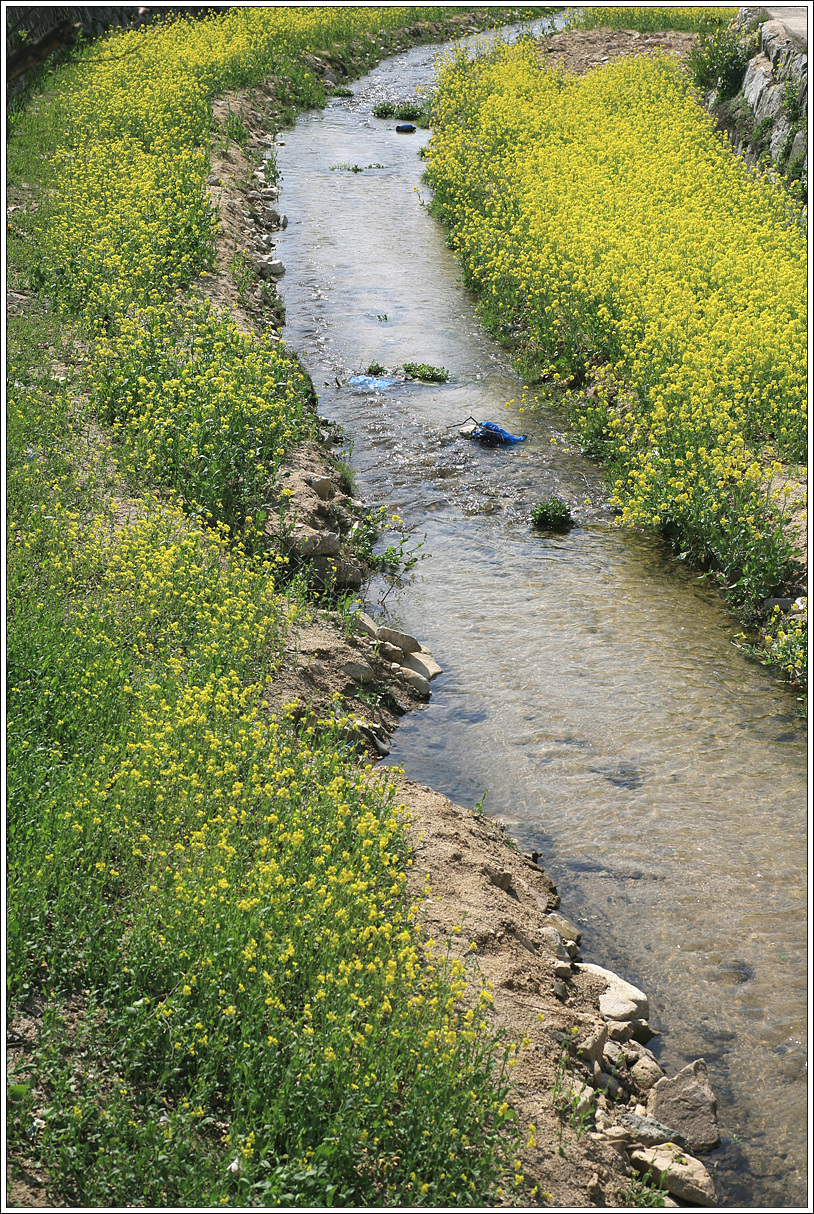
7, 8, 570, 1207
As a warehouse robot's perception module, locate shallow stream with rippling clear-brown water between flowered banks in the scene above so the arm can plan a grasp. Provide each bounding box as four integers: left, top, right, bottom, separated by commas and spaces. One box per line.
278, 26, 807, 1208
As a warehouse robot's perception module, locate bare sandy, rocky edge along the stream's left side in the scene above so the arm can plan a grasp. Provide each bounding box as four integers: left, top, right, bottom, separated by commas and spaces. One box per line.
195, 54, 732, 1208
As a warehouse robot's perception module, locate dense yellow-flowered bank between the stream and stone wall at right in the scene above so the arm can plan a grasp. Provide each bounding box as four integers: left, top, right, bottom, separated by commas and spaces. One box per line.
427, 37, 807, 660
